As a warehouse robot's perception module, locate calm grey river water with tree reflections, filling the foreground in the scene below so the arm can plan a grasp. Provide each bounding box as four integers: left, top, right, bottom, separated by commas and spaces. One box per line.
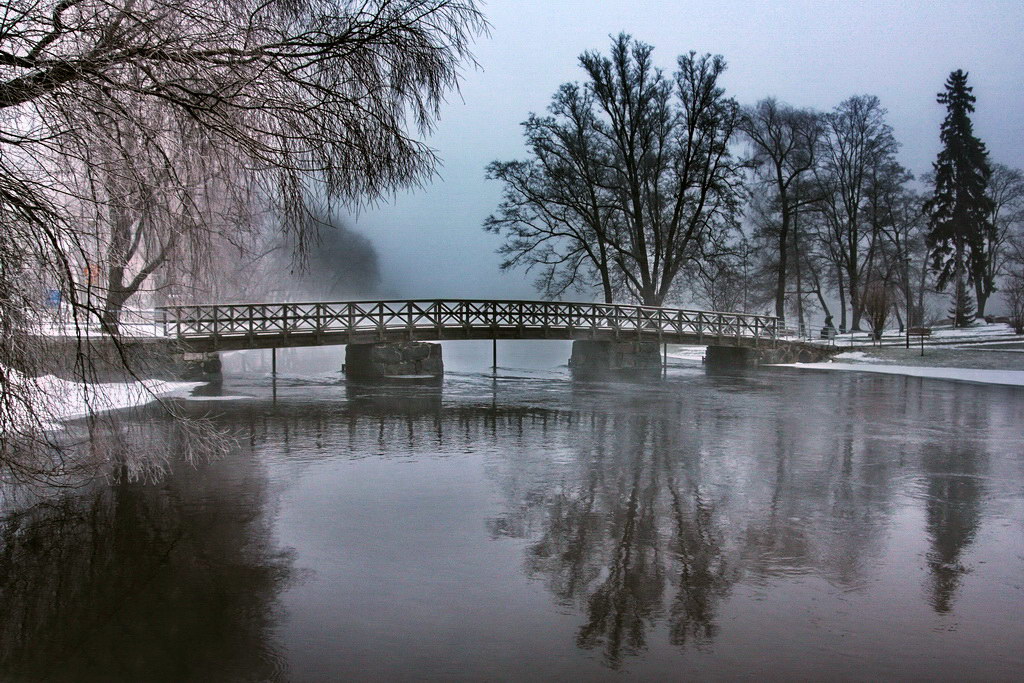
0, 356, 1024, 681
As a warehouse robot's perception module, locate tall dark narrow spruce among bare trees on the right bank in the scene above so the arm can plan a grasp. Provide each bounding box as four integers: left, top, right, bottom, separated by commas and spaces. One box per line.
925, 70, 992, 327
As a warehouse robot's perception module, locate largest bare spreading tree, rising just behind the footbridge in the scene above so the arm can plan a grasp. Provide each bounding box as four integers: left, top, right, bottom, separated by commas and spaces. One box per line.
484, 35, 741, 306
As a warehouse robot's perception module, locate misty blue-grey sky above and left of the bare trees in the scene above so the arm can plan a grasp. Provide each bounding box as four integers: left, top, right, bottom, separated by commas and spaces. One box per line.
355, 0, 1024, 298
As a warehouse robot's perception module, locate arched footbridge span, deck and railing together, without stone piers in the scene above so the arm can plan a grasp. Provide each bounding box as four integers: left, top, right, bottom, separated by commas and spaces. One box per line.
160, 299, 778, 351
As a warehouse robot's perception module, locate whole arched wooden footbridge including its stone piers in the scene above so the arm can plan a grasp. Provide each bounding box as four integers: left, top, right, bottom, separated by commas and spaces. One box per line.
160, 299, 821, 376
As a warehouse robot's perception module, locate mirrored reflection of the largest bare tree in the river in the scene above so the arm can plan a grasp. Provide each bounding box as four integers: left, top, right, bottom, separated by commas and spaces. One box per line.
516, 415, 736, 667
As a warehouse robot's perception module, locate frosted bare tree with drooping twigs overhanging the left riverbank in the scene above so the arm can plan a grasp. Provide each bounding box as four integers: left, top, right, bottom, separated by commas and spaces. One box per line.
0, 0, 486, 481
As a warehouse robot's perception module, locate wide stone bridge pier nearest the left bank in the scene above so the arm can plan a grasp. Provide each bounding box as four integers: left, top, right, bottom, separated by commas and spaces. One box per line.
345, 341, 444, 382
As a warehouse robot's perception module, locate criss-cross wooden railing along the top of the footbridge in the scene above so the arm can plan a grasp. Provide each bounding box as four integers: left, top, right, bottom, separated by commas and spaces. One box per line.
161, 299, 778, 340
